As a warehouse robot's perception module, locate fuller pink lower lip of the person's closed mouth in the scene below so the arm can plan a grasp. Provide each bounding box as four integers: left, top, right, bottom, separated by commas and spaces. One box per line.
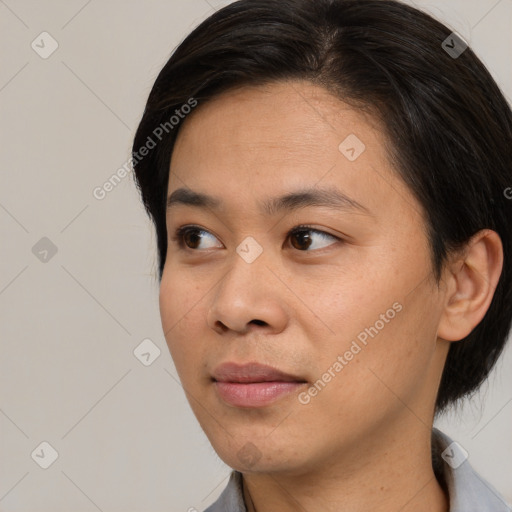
215, 381, 306, 407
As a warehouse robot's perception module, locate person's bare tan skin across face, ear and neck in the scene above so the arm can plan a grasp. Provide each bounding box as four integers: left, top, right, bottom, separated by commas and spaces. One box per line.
160, 81, 502, 512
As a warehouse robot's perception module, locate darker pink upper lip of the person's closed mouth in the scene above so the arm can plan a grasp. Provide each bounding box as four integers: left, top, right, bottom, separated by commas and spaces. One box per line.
212, 362, 306, 383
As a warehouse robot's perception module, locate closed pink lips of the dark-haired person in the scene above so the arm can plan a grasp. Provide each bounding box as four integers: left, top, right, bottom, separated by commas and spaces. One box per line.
212, 363, 307, 408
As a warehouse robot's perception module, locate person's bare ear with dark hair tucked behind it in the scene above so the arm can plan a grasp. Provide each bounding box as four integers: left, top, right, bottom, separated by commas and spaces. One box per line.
437, 229, 503, 341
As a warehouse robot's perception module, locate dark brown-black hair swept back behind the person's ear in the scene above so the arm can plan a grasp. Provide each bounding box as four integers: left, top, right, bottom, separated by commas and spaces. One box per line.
132, 0, 512, 413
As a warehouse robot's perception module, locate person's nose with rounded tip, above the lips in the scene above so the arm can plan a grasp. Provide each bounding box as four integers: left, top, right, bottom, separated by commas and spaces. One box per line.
207, 248, 288, 334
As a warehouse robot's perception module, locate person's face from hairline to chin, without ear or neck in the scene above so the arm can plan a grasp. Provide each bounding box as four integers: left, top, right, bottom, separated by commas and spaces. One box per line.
160, 82, 447, 474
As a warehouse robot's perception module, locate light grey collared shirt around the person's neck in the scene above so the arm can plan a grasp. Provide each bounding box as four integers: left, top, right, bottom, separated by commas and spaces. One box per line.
204, 428, 512, 512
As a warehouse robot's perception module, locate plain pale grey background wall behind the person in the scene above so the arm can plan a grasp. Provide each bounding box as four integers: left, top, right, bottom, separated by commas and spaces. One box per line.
0, 0, 512, 512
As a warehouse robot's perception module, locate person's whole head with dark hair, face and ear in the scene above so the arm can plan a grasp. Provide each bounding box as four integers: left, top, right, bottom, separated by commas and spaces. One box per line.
133, 0, 512, 470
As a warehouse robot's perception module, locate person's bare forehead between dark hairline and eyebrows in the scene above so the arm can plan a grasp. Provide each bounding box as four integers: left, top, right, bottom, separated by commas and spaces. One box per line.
168, 82, 411, 222
